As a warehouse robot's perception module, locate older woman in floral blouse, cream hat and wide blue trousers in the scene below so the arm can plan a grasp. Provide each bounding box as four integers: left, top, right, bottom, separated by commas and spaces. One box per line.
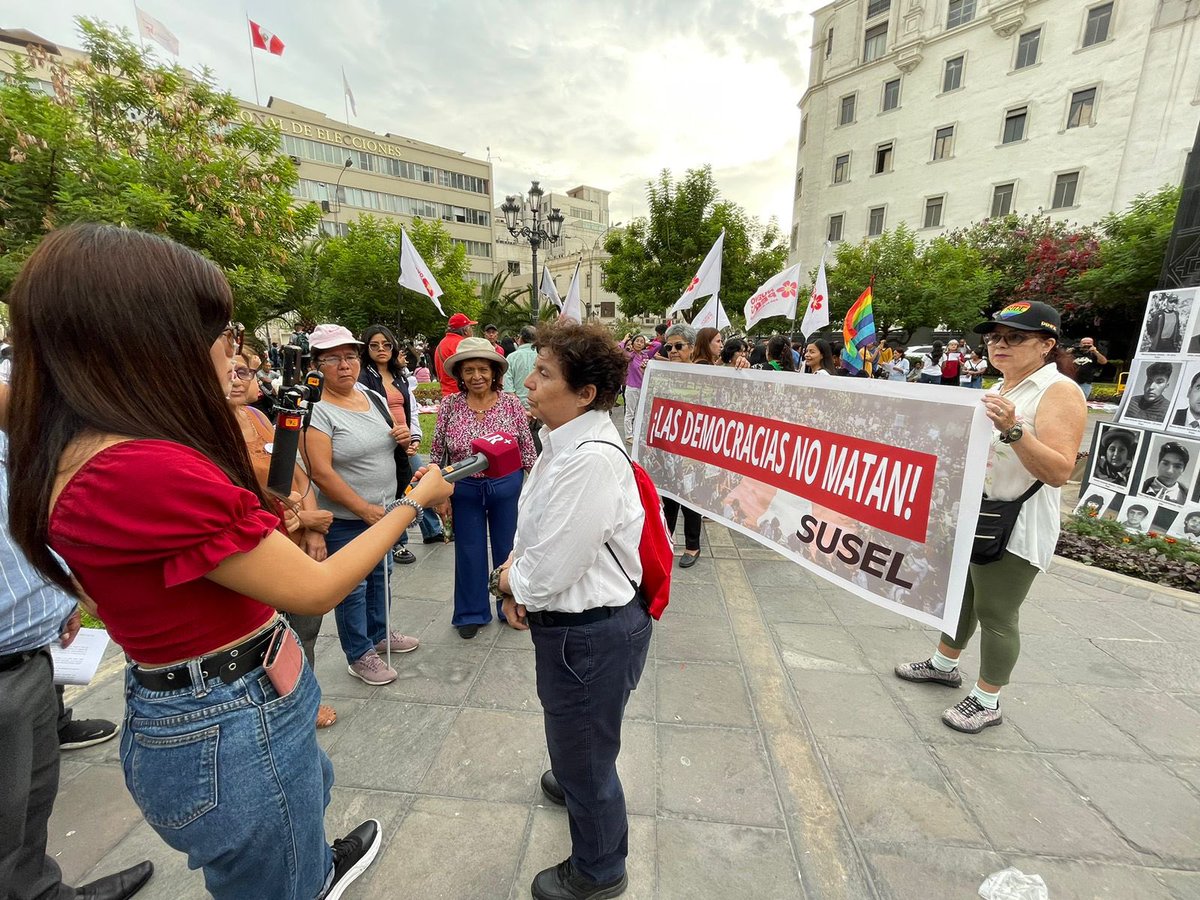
433, 337, 538, 640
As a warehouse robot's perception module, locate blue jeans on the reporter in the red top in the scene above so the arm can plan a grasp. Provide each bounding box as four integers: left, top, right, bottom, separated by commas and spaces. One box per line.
121, 643, 334, 900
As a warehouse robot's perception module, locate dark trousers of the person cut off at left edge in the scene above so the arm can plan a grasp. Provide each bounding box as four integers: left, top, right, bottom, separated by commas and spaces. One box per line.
0, 650, 74, 900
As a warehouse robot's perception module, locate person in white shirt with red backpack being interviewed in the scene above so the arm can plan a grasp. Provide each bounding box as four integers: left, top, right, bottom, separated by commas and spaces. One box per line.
492, 323, 661, 900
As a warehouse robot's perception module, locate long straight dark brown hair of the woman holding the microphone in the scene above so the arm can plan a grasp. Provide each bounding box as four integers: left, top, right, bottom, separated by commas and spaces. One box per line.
8, 224, 268, 594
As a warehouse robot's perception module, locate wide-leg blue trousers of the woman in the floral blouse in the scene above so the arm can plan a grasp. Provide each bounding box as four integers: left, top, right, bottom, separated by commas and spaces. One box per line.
450, 469, 524, 628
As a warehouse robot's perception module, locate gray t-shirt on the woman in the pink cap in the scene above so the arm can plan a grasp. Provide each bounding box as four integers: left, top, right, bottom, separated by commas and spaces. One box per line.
312, 393, 396, 520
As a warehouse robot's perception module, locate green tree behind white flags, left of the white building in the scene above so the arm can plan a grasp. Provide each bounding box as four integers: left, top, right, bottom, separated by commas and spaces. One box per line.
602, 166, 787, 320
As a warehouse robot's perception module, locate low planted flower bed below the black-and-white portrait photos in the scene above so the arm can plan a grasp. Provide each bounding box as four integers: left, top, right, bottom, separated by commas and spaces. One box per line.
1055, 514, 1200, 593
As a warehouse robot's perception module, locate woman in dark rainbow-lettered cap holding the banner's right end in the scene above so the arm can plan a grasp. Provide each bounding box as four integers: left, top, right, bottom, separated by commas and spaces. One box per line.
895, 302, 1087, 734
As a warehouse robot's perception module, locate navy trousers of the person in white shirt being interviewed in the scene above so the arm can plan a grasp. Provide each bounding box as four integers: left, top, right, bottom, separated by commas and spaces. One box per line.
529, 598, 653, 882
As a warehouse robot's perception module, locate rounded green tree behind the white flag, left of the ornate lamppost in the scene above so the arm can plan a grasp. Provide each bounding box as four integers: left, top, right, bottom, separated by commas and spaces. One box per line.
309, 216, 479, 336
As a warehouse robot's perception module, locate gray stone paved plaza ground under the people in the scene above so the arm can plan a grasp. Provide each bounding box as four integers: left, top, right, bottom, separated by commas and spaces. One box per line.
50, 526, 1200, 900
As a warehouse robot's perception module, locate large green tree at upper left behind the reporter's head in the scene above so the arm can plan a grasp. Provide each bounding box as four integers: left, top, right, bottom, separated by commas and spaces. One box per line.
0, 19, 320, 326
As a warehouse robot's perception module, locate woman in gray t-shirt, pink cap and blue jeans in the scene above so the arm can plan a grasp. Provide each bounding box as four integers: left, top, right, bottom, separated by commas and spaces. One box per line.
301, 325, 418, 684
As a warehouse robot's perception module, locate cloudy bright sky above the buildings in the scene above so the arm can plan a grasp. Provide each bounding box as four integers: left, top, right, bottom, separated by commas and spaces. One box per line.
0, 0, 822, 233
